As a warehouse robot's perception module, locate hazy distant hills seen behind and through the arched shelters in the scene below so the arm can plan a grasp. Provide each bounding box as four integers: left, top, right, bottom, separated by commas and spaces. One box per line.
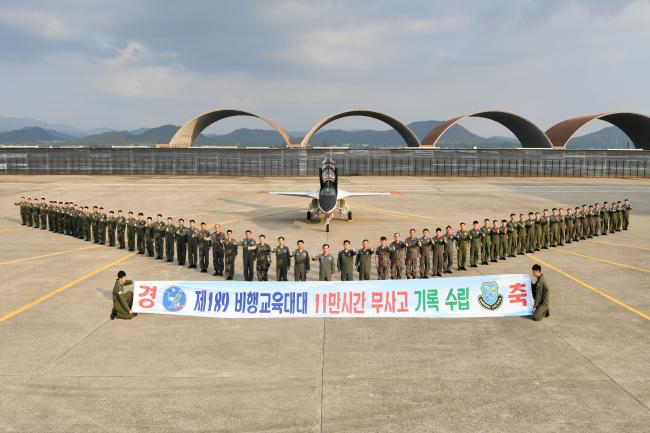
0, 118, 629, 149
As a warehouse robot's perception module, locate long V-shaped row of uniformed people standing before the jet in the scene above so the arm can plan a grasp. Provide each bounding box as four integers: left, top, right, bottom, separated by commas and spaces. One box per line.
16, 197, 631, 281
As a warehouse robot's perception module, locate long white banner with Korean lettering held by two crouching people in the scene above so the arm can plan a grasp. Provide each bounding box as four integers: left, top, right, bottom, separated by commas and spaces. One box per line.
133, 274, 533, 319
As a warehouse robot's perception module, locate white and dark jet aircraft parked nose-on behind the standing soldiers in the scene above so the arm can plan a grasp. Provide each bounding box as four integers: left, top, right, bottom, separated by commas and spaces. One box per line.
260, 156, 396, 232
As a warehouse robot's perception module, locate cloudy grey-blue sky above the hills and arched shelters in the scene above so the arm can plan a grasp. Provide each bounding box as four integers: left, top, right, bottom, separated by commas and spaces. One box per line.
0, 0, 650, 135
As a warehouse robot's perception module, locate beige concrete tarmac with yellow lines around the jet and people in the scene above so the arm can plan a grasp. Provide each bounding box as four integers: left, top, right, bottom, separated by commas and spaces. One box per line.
0, 176, 650, 433
